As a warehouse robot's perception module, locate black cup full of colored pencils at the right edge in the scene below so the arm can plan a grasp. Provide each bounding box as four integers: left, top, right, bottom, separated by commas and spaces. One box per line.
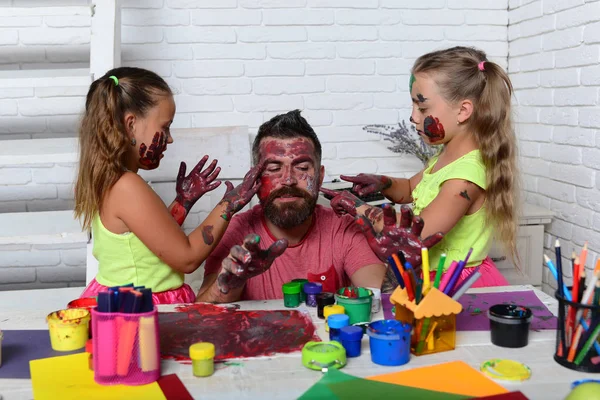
544, 239, 600, 372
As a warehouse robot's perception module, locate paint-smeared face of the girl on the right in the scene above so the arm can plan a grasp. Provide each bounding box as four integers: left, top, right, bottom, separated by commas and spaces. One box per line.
409, 74, 456, 144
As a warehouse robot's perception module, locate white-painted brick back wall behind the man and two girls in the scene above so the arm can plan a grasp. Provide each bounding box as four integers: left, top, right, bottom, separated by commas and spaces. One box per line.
0, 0, 508, 176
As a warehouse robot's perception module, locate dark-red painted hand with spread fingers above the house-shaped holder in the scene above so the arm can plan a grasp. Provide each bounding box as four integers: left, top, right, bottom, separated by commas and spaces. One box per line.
356, 204, 444, 268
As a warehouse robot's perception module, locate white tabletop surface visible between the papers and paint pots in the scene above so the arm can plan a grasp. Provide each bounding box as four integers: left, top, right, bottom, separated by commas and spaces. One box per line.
0, 286, 599, 400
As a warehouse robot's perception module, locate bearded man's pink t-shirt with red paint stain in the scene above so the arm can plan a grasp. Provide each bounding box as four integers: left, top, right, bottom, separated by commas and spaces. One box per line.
204, 205, 382, 300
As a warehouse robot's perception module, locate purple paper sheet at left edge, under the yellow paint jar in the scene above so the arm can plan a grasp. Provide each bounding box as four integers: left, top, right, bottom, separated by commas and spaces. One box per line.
0, 330, 84, 379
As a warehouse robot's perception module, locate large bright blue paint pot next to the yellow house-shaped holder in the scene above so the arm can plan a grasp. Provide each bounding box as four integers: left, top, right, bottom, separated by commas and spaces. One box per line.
367, 319, 412, 365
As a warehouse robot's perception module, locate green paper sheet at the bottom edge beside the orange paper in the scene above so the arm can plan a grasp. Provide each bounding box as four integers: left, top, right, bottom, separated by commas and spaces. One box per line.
299, 368, 472, 400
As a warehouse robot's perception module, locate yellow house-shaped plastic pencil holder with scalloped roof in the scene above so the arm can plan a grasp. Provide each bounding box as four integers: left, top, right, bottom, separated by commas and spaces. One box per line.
390, 287, 462, 356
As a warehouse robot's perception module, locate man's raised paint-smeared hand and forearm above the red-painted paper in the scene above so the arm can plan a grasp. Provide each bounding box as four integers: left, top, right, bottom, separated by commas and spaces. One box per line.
196, 234, 288, 303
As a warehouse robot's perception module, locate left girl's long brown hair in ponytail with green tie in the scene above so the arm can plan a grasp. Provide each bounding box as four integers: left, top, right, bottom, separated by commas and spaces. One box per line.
74, 67, 172, 229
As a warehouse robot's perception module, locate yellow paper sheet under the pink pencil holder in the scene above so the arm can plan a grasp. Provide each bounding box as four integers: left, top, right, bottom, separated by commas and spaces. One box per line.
29, 353, 166, 400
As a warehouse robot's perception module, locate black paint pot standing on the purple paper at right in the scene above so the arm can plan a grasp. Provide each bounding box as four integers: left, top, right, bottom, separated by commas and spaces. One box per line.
487, 304, 532, 348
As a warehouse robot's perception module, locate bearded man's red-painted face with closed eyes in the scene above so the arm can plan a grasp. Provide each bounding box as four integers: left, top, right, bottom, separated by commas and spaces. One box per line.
258, 137, 320, 228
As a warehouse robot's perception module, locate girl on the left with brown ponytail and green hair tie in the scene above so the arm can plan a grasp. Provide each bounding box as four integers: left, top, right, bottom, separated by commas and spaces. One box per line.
75, 67, 260, 304
